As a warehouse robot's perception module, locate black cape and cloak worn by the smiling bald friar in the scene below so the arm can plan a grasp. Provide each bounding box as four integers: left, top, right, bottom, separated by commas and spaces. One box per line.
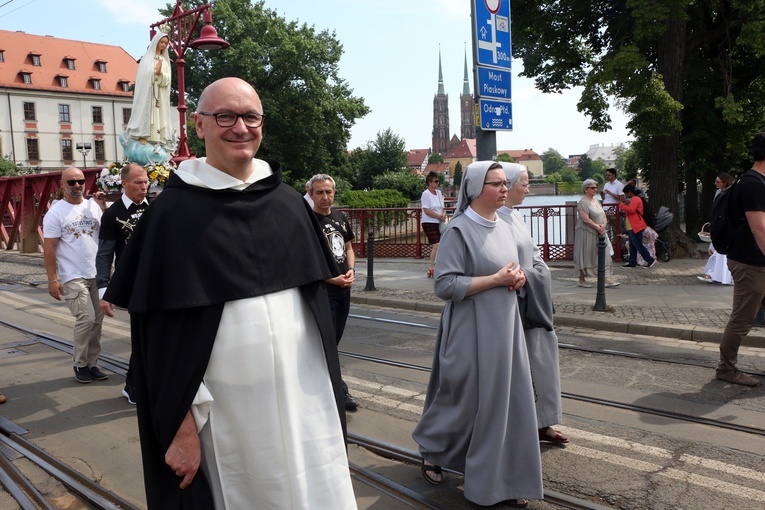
104, 161, 345, 510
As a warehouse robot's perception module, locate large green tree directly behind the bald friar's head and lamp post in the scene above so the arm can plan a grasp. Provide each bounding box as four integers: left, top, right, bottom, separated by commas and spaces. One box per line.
178, 0, 369, 185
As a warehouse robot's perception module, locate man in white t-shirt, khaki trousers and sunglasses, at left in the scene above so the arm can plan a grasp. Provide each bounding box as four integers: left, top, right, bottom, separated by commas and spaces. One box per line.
43, 167, 108, 383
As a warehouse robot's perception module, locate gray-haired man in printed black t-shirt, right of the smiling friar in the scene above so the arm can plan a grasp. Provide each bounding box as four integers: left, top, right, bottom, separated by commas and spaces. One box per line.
306, 174, 359, 411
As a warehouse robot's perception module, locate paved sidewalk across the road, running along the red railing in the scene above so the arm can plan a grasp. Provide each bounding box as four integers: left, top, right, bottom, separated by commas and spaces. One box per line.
0, 252, 765, 347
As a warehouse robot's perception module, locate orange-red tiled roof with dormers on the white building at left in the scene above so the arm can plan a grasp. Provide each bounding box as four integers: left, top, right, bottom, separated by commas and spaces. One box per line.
0, 30, 138, 97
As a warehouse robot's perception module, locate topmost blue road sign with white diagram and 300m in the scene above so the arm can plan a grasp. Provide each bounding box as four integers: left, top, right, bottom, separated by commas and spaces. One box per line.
473, 0, 512, 69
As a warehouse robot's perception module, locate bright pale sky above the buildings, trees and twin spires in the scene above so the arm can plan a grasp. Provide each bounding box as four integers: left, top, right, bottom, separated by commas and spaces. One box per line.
0, 0, 632, 157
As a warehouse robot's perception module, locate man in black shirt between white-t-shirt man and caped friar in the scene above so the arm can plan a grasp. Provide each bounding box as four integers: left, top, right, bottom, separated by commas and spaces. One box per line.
96, 163, 149, 404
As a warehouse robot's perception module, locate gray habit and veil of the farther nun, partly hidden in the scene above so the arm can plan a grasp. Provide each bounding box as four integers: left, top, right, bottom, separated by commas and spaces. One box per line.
497, 163, 563, 429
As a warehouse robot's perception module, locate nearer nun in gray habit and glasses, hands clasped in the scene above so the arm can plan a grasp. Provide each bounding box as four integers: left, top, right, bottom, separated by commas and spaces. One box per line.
412, 161, 543, 506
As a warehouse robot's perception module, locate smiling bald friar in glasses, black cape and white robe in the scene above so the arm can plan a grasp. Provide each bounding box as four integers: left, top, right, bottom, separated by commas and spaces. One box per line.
104, 78, 356, 509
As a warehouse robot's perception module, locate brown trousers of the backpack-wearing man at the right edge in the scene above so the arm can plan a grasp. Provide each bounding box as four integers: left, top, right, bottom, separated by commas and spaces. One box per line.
717, 259, 765, 374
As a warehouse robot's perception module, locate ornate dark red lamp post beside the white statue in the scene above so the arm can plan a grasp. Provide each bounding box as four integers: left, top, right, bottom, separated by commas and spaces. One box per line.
149, 0, 229, 163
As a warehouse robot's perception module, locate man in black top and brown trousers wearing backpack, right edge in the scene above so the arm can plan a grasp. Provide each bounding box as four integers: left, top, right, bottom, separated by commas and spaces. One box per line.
716, 133, 765, 386
